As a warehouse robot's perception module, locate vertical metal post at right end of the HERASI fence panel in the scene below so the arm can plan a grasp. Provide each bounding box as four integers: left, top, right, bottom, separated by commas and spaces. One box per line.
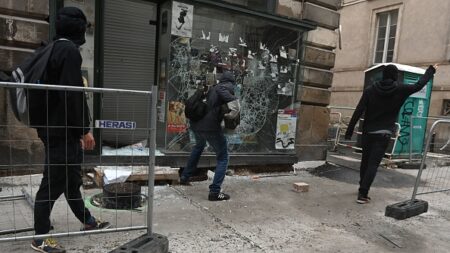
147, 85, 158, 236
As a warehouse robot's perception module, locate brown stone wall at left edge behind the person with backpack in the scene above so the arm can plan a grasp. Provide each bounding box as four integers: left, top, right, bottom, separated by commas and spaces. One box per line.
0, 0, 49, 165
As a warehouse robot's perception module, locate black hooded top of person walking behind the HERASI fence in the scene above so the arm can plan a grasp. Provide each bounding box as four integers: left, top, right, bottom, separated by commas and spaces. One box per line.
38, 7, 90, 141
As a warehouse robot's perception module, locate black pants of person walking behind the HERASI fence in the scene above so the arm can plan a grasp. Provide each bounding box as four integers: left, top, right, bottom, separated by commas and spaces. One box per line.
34, 137, 91, 234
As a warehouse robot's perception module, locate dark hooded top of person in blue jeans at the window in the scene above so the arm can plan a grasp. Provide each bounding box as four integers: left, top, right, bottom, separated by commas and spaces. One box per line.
190, 71, 236, 132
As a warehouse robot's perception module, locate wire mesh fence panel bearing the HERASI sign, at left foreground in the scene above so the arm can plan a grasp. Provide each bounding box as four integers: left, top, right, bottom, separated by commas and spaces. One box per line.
0, 82, 157, 242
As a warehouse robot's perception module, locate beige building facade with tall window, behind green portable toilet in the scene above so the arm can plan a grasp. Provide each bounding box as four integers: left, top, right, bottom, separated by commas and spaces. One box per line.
331, 0, 450, 139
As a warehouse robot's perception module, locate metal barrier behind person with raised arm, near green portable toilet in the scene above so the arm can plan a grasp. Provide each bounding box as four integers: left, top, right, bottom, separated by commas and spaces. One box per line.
328, 106, 401, 159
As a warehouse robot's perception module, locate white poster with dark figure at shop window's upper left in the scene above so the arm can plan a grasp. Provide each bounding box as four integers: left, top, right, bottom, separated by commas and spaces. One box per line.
172, 1, 194, 38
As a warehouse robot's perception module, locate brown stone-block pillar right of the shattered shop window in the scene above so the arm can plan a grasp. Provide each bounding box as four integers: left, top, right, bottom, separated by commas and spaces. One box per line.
277, 0, 341, 160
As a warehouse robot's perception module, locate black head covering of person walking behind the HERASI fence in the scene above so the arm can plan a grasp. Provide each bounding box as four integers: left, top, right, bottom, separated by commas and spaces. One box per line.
55, 7, 87, 46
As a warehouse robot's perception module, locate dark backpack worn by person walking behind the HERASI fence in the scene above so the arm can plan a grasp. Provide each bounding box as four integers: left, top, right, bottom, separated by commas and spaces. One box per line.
9, 39, 67, 126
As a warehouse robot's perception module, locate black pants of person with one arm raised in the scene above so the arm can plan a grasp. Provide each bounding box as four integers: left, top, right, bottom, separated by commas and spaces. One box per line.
359, 134, 391, 195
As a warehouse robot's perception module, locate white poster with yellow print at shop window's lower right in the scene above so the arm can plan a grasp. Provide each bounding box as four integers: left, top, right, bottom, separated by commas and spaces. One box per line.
275, 110, 297, 149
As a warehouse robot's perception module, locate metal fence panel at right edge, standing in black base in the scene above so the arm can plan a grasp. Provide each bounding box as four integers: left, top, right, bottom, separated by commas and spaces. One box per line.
411, 118, 450, 201
